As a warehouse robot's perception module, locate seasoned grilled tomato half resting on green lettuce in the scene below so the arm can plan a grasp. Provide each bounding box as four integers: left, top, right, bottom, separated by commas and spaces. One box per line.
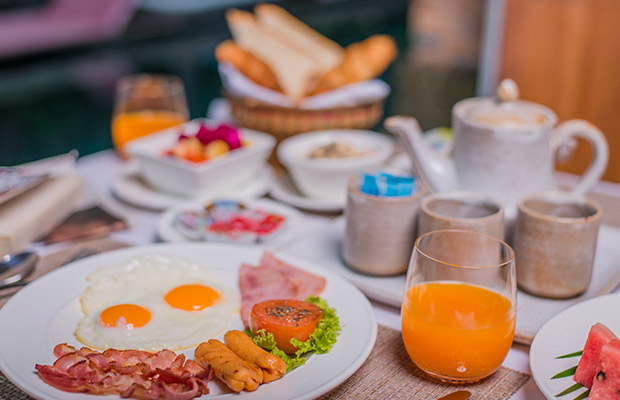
250, 300, 323, 354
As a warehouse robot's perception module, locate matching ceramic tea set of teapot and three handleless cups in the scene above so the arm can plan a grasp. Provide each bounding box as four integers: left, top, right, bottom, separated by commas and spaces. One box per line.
343, 82, 609, 298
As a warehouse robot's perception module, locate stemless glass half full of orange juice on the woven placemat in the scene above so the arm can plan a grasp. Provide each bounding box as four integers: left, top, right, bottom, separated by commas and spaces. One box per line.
401, 230, 516, 383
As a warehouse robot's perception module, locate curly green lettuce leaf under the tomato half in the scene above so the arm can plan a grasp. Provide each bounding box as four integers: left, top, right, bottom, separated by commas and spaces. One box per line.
252, 295, 341, 373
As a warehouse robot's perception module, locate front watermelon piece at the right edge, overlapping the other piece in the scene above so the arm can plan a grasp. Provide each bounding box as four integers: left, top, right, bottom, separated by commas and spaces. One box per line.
588, 339, 620, 400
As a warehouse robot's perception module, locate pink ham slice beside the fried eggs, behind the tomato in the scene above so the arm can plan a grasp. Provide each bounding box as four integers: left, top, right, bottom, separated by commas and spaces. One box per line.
239, 251, 326, 328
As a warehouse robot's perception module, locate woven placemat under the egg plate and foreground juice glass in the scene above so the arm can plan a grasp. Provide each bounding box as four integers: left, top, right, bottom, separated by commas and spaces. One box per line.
0, 239, 530, 400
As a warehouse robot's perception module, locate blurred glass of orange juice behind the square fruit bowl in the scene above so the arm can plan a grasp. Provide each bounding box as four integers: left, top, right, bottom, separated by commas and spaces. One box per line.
112, 74, 189, 158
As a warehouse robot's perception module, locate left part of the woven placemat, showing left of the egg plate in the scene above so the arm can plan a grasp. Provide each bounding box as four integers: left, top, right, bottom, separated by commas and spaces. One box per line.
0, 239, 127, 400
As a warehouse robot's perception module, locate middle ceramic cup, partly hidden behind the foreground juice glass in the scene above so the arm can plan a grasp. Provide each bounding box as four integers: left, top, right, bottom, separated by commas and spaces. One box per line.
417, 191, 504, 240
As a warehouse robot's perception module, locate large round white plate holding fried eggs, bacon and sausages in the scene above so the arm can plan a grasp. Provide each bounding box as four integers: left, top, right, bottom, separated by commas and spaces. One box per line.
0, 243, 377, 400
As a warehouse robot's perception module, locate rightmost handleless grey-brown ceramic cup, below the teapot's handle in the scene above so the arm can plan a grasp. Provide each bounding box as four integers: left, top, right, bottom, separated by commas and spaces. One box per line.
513, 192, 602, 298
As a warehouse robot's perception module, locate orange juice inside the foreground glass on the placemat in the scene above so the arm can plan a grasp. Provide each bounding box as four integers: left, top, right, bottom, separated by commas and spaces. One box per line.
401, 282, 515, 381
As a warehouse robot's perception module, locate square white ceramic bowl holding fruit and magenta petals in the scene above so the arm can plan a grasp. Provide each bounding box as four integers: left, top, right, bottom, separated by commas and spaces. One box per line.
127, 119, 276, 196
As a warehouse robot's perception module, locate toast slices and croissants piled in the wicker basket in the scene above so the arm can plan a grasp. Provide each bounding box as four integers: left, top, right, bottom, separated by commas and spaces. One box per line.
215, 4, 397, 99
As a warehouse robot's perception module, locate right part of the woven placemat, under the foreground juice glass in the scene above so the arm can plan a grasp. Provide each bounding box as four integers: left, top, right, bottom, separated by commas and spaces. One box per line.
319, 326, 530, 400
